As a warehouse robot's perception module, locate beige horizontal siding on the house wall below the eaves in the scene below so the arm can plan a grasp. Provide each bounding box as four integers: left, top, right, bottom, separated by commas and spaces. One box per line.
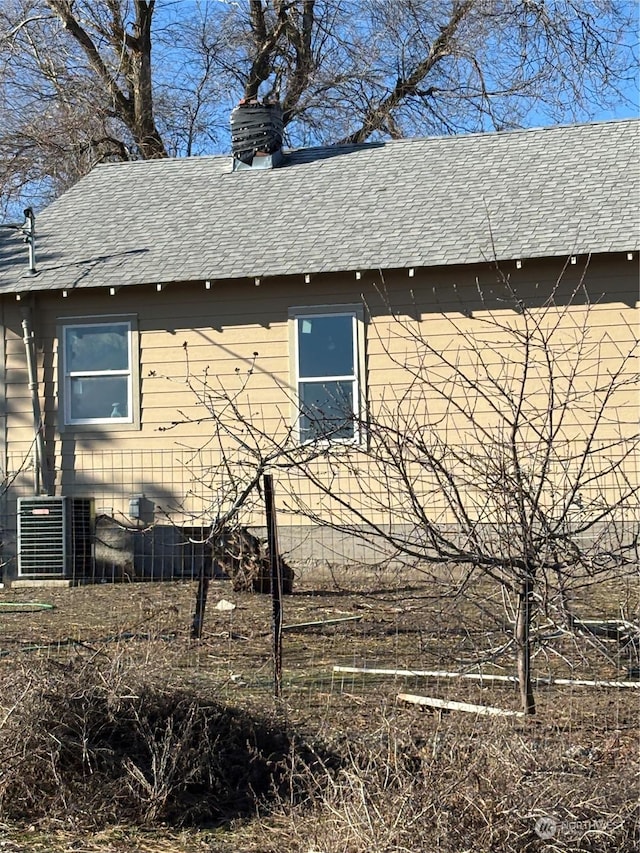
4, 251, 638, 523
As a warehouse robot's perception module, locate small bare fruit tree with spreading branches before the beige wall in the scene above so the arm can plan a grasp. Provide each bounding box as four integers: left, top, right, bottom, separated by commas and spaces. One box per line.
159, 258, 640, 713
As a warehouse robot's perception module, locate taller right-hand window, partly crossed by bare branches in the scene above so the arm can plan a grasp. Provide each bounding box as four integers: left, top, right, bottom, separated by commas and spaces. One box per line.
290, 306, 363, 443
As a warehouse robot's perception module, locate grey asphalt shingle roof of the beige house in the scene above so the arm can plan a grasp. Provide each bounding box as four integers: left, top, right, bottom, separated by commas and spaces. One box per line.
0, 120, 640, 292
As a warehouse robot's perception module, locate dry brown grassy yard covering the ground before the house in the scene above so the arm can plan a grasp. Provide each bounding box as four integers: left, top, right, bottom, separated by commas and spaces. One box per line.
0, 578, 640, 853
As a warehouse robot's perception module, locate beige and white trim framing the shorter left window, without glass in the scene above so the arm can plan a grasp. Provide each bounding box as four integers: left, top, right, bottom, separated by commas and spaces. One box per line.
57, 314, 140, 432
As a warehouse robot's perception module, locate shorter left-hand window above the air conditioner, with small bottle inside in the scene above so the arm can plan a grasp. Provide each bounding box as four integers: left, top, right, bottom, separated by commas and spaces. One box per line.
60, 318, 139, 428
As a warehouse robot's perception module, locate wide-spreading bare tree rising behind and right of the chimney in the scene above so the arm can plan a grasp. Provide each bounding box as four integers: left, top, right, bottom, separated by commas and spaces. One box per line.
202, 0, 637, 144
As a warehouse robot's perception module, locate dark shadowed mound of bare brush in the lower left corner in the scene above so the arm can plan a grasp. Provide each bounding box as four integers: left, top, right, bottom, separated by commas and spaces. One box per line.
0, 662, 330, 827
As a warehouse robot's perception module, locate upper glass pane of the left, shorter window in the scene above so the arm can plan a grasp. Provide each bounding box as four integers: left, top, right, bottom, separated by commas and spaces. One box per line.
65, 323, 129, 373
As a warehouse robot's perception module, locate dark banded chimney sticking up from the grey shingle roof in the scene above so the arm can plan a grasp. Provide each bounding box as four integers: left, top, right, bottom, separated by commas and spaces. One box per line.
231, 101, 283, 172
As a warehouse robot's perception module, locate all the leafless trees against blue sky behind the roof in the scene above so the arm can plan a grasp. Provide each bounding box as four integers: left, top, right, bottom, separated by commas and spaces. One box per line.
0, 0, 637, 209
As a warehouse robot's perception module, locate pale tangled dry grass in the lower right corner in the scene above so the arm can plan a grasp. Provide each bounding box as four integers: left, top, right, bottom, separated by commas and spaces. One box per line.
256, 719, 638, 853
